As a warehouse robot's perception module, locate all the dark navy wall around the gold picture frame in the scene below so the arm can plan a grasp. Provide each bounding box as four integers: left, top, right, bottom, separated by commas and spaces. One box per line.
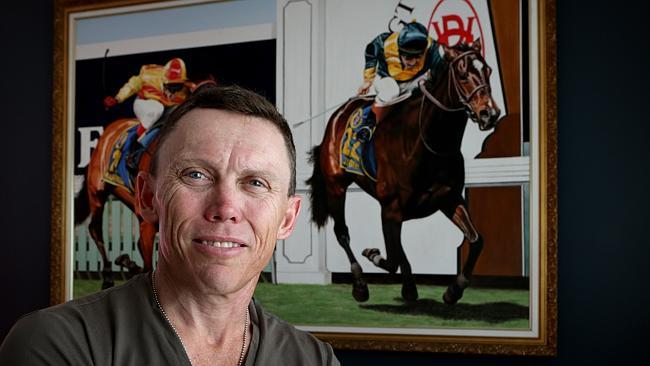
0, 0, 650, 366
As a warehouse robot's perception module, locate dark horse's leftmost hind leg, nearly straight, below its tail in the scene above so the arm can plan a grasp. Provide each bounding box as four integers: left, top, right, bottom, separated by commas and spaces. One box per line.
327, 189, 370, 302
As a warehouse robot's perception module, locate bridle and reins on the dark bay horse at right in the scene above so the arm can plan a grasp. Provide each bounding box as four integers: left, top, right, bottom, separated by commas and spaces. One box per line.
418, 50, 490, 156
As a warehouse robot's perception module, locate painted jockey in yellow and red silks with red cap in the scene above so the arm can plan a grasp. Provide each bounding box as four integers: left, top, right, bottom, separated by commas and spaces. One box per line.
104, 58, 195, 141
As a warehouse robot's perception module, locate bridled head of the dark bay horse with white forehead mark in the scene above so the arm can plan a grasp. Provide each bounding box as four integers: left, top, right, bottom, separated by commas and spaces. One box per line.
442, 39, 501, 131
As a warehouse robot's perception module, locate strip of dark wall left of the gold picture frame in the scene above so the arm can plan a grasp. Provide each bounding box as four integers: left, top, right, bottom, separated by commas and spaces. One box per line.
0, 0, 53, 339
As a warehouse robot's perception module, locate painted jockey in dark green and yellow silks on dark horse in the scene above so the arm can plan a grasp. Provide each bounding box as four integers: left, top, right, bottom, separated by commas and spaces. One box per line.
357, 21, 443, 141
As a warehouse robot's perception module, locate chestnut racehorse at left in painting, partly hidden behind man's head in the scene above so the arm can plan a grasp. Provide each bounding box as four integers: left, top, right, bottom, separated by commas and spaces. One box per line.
74, 119, 158, 289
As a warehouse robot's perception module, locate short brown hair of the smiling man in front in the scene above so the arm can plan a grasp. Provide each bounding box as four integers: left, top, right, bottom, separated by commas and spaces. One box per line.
149, 83, 296, 195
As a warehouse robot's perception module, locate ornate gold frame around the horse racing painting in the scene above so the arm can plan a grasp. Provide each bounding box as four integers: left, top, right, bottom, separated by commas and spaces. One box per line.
50, 0, 558, 356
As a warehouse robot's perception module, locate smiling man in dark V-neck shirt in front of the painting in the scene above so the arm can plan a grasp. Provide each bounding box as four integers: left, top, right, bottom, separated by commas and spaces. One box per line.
0, 84, 339, 366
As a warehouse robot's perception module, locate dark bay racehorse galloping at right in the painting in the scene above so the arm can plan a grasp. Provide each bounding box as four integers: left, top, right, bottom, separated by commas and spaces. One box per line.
307, 41, 501, 304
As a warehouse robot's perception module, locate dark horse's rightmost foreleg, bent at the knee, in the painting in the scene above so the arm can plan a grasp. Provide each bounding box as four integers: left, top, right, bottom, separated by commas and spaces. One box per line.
442, 203, 483, 304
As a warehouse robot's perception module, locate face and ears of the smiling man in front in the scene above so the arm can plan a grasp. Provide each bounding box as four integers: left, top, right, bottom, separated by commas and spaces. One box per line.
138, 109, 300, 294
